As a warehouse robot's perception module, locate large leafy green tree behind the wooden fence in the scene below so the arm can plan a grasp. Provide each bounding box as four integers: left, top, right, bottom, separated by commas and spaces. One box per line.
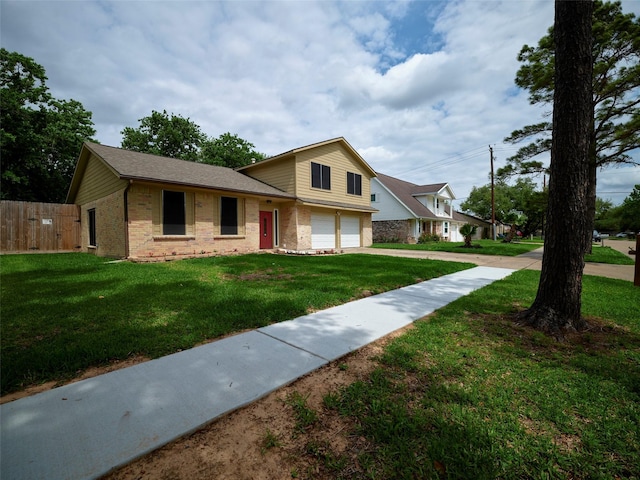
0, 48, 95, 203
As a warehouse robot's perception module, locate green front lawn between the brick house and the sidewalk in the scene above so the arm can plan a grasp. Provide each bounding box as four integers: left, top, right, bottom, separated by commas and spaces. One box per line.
0, 254, 472, 394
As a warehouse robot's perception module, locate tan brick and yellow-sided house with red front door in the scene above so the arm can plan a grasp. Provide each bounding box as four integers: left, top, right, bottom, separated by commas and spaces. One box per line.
67, 138, 375, 259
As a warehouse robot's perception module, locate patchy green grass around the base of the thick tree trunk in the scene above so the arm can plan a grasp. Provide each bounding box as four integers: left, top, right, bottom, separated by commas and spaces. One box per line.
325, 270, 640, 479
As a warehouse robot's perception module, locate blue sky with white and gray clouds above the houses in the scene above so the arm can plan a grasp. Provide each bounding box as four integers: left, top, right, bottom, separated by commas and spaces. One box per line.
0, 0, 640, 205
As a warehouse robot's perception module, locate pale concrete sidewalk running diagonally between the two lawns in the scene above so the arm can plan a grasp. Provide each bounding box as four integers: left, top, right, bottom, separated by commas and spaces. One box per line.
0, 266, 512, 480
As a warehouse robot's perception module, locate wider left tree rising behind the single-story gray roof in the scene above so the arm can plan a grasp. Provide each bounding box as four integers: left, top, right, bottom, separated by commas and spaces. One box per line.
120, 110, 207, 162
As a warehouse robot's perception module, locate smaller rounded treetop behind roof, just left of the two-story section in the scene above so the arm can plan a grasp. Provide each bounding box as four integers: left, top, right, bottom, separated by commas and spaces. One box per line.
200, 132, 265, 168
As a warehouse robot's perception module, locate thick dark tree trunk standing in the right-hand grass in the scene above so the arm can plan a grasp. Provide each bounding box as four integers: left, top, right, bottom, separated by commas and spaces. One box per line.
518, 0, 593, 336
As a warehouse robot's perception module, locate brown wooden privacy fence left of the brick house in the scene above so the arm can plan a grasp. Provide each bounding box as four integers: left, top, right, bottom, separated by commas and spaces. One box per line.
0, 200, 81, 253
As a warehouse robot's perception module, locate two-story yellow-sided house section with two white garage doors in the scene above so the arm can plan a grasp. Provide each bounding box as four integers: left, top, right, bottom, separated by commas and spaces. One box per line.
239, 137, 376, 251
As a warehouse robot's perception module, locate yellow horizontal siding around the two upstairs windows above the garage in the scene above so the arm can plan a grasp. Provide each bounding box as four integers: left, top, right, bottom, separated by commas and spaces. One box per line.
296, 143, 371, 206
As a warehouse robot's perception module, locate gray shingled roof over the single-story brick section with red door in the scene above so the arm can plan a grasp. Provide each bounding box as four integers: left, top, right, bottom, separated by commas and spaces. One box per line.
85, 142, 295, 199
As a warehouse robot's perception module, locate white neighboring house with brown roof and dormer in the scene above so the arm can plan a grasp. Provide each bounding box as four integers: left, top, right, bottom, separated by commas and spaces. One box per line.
371, 173, 467, 243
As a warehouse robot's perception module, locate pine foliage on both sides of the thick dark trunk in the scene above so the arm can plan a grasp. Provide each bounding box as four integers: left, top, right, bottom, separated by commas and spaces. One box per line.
497, 0, 640, 250
